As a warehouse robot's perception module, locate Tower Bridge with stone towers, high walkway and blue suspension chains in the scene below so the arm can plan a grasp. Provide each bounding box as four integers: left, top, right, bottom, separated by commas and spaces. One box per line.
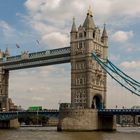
0, 9, 140, 131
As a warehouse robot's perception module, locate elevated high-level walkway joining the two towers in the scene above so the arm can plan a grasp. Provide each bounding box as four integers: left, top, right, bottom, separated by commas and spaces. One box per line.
0, 47, 70, 70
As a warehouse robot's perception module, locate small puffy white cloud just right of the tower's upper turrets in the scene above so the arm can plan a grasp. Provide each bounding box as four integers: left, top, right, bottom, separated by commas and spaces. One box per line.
112, 31, 134, 42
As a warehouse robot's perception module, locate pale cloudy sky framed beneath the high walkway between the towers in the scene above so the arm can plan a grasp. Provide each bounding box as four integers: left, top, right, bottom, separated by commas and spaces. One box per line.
9, 64, 71, 108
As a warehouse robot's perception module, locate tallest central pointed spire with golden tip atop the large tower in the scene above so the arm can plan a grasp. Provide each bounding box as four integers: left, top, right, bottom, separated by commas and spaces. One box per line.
83, 7, 95, 29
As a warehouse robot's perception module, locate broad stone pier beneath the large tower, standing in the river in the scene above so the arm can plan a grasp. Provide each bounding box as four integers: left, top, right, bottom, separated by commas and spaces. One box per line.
58, 109, 116, 131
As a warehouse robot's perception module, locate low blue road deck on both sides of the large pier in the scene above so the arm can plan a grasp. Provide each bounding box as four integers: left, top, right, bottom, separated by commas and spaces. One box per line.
0, 109, 140, 121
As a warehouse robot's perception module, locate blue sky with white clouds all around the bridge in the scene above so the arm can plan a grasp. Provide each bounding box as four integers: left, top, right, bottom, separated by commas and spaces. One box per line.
0, 0, 140, 109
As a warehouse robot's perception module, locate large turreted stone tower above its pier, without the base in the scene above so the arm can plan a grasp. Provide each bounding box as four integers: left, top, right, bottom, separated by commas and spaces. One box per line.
70, 9, 108, 109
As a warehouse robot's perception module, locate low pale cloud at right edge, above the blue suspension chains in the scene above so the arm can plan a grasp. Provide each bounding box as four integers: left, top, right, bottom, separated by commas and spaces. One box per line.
120, 61, 140, 69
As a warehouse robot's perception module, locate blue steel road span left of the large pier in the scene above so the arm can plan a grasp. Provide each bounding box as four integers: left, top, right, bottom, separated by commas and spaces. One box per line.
0, 110, 59, 121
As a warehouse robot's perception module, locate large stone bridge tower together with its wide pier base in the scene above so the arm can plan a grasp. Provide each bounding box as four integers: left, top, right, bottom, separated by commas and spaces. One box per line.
58, 9, 116, 131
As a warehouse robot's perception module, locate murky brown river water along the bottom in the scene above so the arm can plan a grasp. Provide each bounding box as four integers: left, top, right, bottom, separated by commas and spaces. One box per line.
0, 127, 140, 140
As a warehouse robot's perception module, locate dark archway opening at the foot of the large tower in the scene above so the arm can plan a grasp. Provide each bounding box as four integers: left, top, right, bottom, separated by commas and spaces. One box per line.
91, 95, 103, 109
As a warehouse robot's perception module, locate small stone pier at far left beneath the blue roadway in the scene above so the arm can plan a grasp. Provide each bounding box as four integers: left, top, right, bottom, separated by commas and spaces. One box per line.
0, 119, 20, 129
